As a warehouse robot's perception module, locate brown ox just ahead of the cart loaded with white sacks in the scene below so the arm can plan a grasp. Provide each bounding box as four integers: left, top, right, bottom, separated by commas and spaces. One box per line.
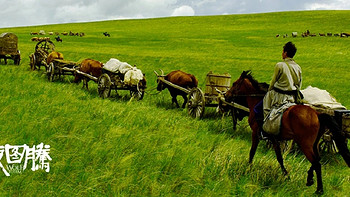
74, 59, 103, 89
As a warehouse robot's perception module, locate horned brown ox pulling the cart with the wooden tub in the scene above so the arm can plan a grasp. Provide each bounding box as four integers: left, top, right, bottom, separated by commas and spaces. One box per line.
157, 70, 198, 108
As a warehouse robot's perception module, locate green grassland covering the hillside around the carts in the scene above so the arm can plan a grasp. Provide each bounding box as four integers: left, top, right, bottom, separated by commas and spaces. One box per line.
0, 11, 350, 196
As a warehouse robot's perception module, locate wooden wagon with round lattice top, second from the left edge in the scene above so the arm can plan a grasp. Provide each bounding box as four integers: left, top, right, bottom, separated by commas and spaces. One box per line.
29, 40, 55, 70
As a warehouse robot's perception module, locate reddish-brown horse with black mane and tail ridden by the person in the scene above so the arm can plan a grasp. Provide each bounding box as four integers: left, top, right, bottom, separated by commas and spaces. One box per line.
225, 71, 350, 194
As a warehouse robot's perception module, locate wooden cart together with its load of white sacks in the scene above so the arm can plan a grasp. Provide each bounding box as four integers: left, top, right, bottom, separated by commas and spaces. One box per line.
97, 58, 146, 100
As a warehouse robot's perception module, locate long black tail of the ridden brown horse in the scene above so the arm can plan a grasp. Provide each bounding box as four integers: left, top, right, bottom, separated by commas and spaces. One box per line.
318, 114, 350, 167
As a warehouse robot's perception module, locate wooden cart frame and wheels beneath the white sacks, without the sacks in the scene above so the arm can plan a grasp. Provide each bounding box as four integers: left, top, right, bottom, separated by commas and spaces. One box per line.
97, 68, 146, 100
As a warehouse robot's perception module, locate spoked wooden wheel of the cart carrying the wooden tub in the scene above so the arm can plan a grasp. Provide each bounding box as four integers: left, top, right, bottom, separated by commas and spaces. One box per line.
187, 88, 205, 118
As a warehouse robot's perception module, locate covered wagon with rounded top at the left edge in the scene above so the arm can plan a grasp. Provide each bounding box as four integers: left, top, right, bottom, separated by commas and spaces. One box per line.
0, 33, 21, 65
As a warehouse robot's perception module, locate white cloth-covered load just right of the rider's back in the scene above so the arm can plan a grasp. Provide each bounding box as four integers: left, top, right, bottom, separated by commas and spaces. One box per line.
301, 86, 346, 110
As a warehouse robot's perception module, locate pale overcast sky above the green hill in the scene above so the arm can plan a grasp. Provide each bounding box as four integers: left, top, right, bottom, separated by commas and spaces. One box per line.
0, 0, 350, 28
